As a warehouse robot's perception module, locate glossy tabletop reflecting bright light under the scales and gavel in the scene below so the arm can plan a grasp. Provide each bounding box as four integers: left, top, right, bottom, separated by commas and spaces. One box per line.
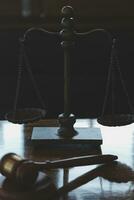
0, 119, 134, 200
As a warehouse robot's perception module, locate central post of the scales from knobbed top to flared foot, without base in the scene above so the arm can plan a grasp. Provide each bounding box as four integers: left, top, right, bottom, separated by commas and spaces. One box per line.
58, 6, 77, 138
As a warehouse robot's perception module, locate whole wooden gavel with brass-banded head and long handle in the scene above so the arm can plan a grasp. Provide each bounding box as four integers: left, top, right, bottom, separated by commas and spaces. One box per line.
0, 153, 118, 186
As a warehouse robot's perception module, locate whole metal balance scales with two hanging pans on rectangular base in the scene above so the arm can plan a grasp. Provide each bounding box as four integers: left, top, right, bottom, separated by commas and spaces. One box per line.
6, 6, 134, 146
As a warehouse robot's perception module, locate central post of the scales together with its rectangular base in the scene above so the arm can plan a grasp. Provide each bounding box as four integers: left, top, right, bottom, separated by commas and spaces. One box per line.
32, 6, 102, 148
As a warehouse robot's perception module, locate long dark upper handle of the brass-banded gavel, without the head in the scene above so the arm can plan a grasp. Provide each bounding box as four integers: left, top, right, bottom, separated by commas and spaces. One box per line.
35, 154, 118, 170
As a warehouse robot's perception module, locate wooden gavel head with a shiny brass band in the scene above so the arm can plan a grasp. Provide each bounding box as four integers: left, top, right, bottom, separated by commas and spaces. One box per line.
0, 153, 38, 186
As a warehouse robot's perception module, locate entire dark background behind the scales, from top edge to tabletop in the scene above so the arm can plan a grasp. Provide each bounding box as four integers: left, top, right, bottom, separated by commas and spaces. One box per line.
0, 0, 134, 119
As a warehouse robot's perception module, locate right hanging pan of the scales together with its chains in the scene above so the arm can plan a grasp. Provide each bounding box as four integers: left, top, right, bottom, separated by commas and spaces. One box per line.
97, 39, 134, 126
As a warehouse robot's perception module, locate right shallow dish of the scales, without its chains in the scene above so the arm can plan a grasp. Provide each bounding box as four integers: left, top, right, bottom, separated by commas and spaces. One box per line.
97, 114, 134, 126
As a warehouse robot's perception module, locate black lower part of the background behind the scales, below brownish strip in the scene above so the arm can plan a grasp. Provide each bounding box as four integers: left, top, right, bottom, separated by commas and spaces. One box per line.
0, 26, 134, 119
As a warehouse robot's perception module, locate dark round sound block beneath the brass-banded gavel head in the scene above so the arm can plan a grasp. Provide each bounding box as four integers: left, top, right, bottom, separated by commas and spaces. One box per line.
0, 172, 57, 200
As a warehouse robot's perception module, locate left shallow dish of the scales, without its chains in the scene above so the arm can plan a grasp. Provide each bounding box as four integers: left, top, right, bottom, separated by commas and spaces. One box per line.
5, 108, 46, 124
